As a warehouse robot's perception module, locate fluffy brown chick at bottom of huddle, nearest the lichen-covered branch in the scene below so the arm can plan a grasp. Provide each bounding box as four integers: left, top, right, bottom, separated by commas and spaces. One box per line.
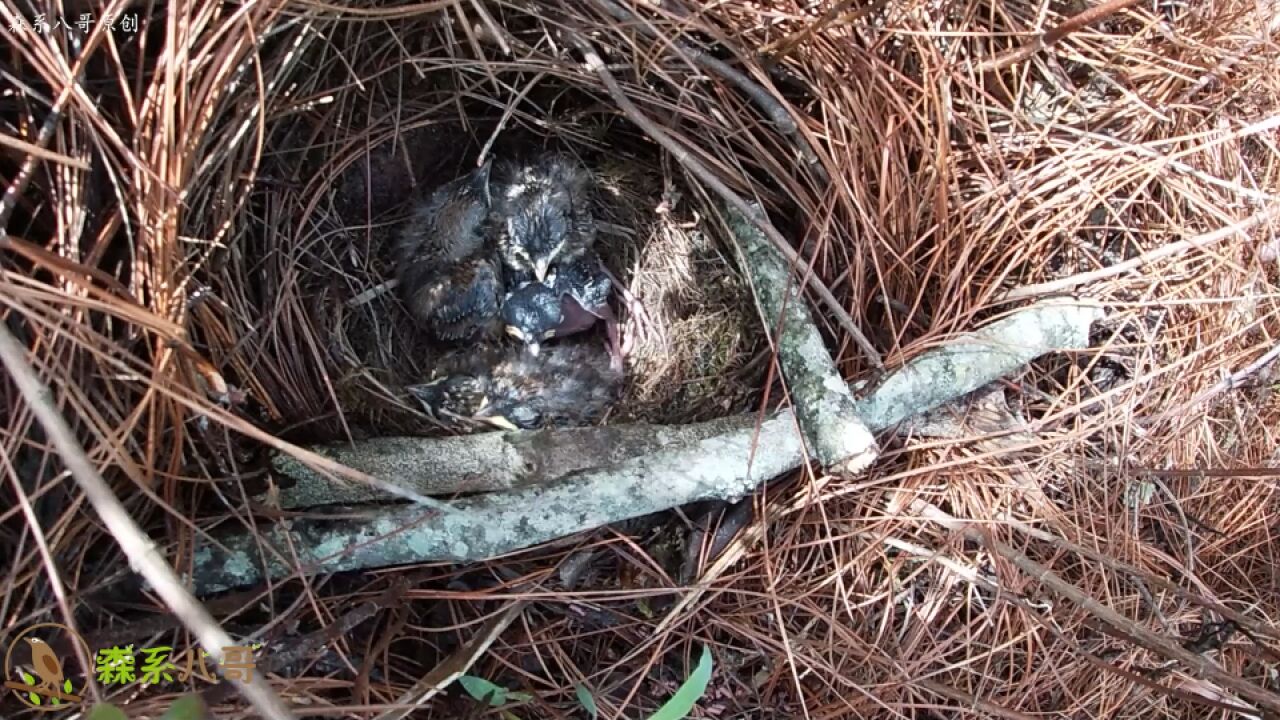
407, 343, 622, 430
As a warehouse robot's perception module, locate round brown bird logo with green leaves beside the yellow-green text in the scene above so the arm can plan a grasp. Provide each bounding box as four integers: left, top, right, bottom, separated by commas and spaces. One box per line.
4, 623, 92, 710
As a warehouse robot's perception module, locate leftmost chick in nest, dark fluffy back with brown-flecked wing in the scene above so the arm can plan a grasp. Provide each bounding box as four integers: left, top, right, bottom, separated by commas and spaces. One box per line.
394, 161, 502, 342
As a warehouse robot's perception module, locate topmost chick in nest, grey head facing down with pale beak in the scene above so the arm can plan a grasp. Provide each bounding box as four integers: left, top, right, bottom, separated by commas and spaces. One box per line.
494, 154, 595, 282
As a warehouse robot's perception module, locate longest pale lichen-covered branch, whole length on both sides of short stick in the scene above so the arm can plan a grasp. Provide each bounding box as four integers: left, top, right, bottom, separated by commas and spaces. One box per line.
192, 294, 1102, 594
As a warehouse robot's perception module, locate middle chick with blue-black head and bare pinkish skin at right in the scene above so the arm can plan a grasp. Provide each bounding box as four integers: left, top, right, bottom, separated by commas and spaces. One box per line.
502, 251, 622, 370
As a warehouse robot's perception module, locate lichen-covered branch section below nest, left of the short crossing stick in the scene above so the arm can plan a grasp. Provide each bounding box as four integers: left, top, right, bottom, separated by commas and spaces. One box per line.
193, 414, 801, 594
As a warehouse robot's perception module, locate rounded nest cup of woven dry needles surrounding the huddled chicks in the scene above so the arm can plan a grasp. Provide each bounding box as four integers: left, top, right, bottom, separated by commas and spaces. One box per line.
202, 6, 788, 441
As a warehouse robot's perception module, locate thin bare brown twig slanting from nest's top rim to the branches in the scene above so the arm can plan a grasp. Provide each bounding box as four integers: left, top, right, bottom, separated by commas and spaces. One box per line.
571, 35, 884, 369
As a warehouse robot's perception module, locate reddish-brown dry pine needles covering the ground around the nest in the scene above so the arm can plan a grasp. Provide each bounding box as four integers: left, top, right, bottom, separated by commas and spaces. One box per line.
0, 0, 1280, 717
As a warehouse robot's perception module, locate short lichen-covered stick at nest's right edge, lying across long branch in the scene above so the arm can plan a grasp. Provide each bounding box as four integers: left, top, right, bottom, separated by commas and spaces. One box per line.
726, 202, 878, 474
